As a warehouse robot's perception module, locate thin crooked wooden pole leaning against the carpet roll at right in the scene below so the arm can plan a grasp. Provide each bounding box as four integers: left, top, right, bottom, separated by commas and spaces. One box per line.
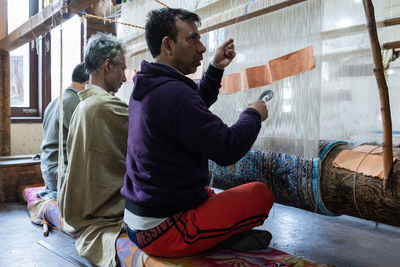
363, 0, 393, 188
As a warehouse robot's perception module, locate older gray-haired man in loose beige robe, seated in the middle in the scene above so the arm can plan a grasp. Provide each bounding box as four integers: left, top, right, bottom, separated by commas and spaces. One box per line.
58, 33, 129, 266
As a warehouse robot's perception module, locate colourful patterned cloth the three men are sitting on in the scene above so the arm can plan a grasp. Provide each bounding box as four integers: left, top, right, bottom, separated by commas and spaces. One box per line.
23, 186, 326, 267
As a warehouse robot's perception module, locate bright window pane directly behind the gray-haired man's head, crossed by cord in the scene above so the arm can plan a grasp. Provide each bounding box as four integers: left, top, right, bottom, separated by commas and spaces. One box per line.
51, 16, 81, 100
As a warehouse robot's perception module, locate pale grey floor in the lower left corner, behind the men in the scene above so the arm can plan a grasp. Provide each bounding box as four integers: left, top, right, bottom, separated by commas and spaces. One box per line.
0, 203, 92, 267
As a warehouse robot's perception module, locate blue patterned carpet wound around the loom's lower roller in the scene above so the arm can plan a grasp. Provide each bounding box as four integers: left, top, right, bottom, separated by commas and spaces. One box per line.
209, 141, 346, 216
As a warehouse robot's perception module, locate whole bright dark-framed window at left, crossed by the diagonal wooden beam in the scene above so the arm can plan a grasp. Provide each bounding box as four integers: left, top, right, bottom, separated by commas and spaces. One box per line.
7, 0, 82, 122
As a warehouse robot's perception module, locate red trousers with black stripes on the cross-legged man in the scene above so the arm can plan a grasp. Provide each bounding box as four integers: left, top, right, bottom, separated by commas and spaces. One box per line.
128, 182, 273, 257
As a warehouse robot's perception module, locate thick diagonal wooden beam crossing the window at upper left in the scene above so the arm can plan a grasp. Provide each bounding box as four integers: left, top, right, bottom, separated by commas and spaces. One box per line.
0, 0, 99, 51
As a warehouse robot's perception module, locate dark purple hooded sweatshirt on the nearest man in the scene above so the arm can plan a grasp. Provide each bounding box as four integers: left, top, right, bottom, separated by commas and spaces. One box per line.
121, 61, 261, 218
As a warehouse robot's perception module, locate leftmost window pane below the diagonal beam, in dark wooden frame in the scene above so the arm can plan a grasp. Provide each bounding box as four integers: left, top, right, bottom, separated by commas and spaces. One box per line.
10, 43, 30, 107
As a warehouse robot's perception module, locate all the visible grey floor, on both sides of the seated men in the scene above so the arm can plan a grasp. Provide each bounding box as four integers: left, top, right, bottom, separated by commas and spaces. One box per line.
0, 203, 400, 267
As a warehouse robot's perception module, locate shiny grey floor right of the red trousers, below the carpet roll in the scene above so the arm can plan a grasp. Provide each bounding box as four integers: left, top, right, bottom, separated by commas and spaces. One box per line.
262, 204, 400, 267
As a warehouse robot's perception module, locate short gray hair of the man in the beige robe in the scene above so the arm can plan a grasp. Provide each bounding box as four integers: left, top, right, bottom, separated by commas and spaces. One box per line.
85, 32, 125, 74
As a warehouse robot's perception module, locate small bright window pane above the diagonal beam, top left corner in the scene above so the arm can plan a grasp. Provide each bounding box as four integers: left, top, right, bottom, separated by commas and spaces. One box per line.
7, 0, 29, 33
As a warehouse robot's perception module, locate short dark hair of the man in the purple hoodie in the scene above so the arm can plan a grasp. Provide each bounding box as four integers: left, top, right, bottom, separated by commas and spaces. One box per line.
146, 7, 200, 58
